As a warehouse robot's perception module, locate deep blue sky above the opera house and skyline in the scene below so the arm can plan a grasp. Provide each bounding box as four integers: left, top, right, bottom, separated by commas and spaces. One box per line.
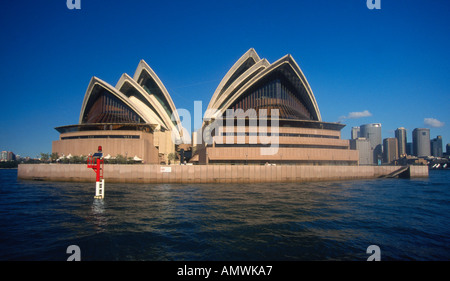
0, 0, 450, 157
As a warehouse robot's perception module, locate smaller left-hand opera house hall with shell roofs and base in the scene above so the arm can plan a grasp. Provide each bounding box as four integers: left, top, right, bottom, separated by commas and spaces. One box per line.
52, 60, 185, 164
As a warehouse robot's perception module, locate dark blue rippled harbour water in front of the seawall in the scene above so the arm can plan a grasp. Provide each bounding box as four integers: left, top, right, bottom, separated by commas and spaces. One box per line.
0, 167, 450, 261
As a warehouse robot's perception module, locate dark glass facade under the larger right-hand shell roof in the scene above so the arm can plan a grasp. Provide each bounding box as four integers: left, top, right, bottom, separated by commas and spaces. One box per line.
230, 77, 314, 120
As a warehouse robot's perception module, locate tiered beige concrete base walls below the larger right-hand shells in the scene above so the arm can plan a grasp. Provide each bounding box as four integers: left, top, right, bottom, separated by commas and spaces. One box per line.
197, 126, 359, 165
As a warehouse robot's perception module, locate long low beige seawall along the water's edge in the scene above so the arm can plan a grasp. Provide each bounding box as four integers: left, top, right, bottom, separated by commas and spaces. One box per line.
17, 164, 428, 183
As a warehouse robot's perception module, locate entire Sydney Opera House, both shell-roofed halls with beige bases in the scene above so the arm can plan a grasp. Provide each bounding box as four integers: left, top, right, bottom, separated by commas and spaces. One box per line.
52, 49, 358, 165
